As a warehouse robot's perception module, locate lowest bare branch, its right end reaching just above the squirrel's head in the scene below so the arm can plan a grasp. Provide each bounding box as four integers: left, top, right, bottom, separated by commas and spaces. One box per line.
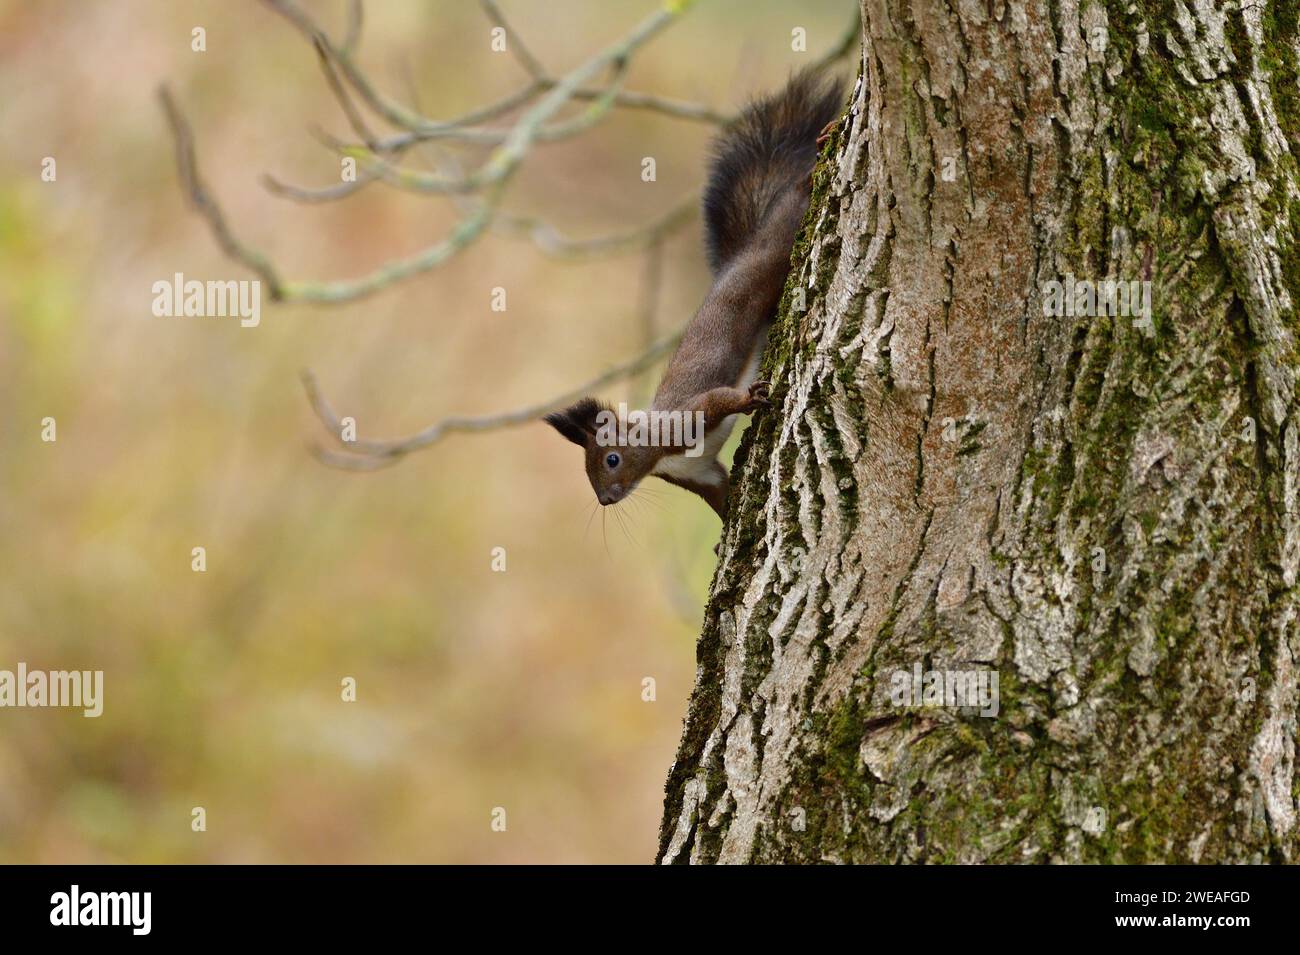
303, 329, 681, 470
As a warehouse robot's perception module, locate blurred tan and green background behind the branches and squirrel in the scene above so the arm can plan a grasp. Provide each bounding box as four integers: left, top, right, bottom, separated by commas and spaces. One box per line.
0, 0, 854, 863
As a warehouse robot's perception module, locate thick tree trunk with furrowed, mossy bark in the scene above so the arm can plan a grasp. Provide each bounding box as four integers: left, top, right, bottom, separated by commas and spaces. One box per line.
659, 0, 1300, 863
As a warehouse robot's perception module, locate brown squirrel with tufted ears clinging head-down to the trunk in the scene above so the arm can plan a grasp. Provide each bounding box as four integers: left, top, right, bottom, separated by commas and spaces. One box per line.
546, 70, 844, 522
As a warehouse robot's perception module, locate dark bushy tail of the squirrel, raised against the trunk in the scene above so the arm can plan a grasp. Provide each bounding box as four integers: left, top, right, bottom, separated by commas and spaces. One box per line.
705, 69, 844, 272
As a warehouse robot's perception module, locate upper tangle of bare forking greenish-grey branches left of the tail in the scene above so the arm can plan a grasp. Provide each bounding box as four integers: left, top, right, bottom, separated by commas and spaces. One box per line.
167, 0, 861, 310
